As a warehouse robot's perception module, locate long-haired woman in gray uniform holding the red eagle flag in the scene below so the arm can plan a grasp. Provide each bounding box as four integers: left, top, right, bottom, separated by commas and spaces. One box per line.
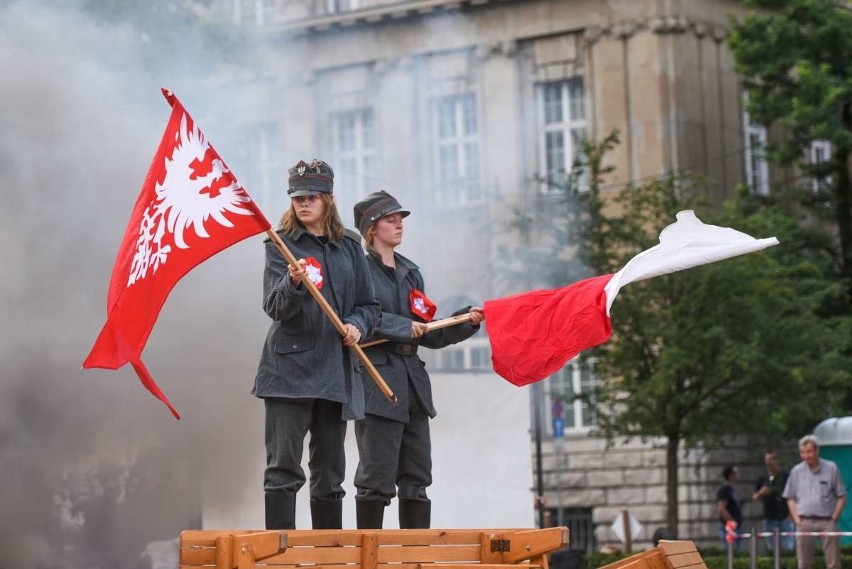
252, 160, 379, 529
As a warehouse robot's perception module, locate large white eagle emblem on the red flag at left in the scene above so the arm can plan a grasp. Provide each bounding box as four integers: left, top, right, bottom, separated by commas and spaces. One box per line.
127, 112, 253, 287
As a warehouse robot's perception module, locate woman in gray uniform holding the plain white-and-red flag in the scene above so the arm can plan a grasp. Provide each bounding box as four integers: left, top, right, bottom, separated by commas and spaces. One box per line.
355, 191, 483, 529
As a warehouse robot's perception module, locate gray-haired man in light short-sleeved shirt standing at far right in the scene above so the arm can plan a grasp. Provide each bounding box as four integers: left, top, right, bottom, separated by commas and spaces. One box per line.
784, 435, 846, 569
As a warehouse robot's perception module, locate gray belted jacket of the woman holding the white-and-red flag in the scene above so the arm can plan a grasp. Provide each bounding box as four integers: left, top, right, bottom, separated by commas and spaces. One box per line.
364, 251, 479, 423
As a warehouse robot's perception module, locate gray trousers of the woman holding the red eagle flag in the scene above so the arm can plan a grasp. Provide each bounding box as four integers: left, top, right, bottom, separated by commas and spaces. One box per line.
263, 398, 346, 500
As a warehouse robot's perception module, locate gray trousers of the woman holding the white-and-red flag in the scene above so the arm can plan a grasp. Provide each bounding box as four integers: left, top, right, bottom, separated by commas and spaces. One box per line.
355, 400, 432, 505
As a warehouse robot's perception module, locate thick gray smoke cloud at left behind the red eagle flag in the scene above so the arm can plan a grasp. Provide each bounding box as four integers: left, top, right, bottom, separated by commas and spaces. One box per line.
0, 1, 268, 569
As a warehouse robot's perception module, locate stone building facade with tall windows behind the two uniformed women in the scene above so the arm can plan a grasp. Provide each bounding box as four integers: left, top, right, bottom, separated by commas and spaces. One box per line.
205, 0, 780, 549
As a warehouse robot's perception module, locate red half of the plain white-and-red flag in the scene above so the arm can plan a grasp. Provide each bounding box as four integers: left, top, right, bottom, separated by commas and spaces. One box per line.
484, 274, 613, 386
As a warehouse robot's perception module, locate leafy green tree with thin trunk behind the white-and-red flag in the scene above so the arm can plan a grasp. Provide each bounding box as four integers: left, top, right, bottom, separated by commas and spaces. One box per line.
516, 135, 852, 532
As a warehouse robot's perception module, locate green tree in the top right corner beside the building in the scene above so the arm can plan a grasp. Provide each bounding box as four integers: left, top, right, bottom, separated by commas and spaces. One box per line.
728, 0, 852, 294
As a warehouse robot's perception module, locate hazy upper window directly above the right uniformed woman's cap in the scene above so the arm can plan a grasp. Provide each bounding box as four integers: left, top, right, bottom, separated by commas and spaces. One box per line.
333, 109, 376, 201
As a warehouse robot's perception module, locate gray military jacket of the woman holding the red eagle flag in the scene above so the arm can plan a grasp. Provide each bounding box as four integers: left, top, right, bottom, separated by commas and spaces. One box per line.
252, 224, 379, 419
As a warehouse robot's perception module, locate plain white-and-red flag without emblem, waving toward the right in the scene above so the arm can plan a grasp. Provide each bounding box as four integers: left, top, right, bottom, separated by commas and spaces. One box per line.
484, 211, 778, 385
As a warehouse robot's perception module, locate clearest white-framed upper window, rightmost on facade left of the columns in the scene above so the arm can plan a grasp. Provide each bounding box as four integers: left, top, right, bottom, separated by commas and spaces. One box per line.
538, 77, 589, 194
